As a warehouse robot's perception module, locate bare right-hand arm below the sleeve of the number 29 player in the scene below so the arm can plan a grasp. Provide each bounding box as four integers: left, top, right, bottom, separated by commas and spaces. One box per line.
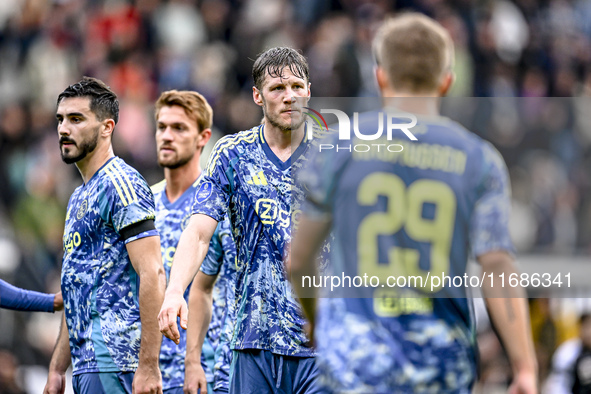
478, 251, 538, 394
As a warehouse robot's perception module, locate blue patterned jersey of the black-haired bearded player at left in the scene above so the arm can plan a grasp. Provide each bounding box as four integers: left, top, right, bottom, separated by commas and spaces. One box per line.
61, 157, 158, 375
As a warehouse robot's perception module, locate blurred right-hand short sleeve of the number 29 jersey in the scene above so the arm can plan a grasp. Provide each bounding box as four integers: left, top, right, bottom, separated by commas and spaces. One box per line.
470, 144, 514, 257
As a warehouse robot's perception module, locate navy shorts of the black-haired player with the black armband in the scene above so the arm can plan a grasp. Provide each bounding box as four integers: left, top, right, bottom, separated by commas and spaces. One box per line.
72, 372, 134, 394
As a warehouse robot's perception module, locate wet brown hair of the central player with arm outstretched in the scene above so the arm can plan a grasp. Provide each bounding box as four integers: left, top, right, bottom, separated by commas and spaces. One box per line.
252, 47, 310, 90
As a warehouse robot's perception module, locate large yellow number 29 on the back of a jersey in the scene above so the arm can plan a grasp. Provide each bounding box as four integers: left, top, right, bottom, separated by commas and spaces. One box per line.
357, 172, 457, 292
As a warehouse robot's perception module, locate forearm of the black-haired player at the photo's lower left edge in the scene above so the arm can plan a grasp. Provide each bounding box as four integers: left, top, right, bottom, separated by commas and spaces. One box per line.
43, 313, 72, 394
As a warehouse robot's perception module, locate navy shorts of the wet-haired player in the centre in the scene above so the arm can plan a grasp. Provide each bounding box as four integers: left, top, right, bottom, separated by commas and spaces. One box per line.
229, 349, 324, 394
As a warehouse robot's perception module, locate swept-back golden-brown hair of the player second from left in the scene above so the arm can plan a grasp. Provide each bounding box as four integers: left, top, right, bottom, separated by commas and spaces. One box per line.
155, 90, 213, 132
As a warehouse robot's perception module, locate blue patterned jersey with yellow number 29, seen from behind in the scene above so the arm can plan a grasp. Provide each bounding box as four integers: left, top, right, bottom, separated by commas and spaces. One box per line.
298, 113, 513, 393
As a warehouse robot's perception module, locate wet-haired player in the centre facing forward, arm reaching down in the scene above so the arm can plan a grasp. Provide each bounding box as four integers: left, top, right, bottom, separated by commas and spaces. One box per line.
159, 48, 318, 394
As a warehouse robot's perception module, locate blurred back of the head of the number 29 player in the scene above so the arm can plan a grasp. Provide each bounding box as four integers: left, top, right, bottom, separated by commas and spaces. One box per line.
373, 13, 453, 94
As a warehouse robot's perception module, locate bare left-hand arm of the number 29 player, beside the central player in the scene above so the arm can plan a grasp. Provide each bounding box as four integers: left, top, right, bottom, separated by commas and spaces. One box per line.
286, 214, 331, 341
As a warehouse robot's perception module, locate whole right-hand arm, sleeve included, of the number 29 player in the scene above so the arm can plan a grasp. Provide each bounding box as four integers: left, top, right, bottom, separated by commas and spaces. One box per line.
470, 145, 537, 394
